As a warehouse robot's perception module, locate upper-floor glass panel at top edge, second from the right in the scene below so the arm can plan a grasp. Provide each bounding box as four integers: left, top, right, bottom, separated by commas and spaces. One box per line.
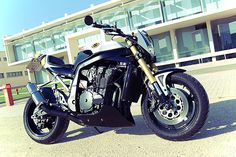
162, 0, 202, 21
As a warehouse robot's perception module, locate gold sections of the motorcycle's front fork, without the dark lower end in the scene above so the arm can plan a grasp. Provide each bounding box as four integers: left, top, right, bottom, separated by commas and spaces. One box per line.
127, 40, 157, 84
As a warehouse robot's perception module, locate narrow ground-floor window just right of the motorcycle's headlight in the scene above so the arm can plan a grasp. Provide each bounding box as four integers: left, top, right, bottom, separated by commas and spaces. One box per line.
152, 32, 174, 62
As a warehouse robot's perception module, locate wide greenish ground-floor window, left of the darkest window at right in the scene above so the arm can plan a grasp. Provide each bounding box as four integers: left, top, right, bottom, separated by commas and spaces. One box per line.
176, 23, 210, 58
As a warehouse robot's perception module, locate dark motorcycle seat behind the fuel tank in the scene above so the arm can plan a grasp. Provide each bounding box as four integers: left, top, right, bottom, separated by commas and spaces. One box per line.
46, 55, 74, 78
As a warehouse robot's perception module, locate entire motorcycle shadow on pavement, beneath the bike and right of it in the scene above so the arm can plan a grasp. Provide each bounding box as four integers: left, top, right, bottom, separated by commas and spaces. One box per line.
59, 99, 236, 143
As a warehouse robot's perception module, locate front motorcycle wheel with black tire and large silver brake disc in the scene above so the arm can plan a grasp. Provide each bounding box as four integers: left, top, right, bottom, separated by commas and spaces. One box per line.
142, 73, 209, 141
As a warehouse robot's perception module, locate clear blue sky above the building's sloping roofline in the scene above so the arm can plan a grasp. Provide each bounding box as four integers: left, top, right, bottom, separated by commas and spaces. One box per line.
0, 0, 109, 51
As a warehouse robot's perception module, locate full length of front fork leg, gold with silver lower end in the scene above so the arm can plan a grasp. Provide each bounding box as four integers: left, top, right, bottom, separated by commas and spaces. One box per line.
126, 40, 163, 96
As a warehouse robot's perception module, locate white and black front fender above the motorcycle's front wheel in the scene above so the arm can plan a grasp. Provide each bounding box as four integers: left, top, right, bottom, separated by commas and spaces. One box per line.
154, 68, 186, 96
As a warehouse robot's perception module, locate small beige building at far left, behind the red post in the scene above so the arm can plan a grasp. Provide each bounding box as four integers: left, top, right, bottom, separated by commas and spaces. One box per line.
0, 51, 28, 87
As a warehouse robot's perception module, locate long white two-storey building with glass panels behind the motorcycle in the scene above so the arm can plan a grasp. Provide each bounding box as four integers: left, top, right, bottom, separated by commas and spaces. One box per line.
4, 0, 236, 83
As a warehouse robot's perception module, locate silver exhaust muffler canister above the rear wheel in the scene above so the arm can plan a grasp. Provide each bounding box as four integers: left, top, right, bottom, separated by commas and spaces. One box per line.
26, 82, 47, 106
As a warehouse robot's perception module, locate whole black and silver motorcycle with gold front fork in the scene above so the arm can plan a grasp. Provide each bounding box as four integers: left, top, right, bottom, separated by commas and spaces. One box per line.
23, 16, 209, 144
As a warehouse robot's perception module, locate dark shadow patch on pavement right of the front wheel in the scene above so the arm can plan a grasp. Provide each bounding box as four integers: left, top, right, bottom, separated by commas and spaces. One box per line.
193, 99, 236, 140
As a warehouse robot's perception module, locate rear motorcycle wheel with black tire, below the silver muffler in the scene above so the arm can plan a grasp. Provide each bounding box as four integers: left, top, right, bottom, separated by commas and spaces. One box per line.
23, 98, 69, 144
